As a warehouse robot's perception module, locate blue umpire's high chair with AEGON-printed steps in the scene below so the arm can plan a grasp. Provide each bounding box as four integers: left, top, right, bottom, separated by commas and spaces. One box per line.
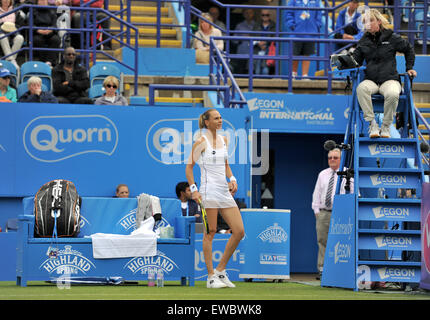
321, 68, 426, 290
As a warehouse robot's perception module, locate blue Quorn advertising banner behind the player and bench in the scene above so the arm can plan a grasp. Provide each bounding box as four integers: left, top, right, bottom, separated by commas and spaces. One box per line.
0, 103, 251, 198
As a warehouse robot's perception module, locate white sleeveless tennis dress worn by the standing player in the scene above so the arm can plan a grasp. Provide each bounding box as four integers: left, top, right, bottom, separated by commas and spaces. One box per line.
197, 135, 237, 208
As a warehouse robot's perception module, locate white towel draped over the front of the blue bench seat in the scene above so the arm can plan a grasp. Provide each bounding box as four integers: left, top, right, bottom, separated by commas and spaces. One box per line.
91, 217, 157, 259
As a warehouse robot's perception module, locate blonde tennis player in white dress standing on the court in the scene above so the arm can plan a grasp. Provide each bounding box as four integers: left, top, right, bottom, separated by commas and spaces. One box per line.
185, 109, 245, 288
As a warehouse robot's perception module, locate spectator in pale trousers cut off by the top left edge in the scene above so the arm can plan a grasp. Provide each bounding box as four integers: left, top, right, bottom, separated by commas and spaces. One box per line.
0, 0, 24, 70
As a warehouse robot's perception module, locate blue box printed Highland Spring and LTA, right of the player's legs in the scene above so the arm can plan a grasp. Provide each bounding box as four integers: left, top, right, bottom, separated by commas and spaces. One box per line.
239, 209, 291, 279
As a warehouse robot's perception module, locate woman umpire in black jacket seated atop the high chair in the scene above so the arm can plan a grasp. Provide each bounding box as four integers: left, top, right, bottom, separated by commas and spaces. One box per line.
352, 9, 417, 138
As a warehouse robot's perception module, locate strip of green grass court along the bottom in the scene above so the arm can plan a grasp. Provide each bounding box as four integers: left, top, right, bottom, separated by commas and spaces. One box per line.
0, 281, 430, 301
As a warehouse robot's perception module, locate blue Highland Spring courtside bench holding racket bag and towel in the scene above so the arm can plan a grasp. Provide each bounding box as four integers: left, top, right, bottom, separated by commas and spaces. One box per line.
16, 197, 195, 287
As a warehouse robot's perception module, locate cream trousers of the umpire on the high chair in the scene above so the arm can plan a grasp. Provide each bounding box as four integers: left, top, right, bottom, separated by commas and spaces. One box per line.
357, 80, 402, 126
